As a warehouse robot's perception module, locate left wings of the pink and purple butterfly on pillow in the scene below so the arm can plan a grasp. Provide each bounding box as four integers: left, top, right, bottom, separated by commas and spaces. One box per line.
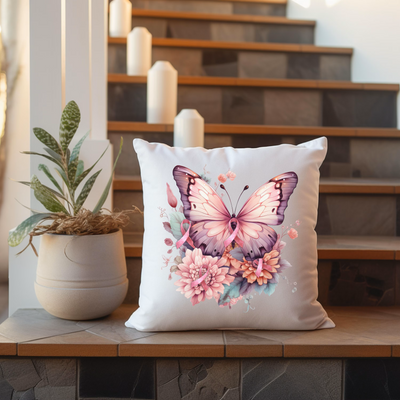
173, 165, 231, 256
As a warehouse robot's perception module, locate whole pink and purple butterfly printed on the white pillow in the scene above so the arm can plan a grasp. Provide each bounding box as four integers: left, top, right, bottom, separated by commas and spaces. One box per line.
173, 165, 298, 260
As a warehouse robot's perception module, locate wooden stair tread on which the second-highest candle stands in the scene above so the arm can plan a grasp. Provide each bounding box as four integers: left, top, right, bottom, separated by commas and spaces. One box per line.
108, 74, 400, 92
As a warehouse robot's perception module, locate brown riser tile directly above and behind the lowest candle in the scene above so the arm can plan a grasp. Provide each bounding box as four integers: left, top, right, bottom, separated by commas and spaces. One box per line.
178, 86, 222, 124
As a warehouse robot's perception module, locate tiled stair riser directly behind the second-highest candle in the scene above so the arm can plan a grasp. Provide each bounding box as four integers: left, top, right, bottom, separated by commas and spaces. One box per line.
108, 43, 351, 81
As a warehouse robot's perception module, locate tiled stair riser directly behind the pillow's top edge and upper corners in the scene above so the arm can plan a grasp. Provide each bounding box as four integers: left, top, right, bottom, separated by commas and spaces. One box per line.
108, 132, 400, 178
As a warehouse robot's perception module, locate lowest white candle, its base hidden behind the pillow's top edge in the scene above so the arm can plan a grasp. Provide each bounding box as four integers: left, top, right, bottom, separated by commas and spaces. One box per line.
174, 109, 204, 147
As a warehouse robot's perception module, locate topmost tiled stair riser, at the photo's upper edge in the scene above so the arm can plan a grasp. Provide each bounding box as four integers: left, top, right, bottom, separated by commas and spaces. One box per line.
126, 0, 286, 17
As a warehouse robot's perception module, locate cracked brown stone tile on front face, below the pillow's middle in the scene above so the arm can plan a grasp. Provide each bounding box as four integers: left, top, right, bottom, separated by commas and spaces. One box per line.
157, 359, 240, 400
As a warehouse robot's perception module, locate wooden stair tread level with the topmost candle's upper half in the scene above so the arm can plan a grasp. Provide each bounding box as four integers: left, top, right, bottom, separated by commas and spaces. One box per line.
132, 8, 316, 26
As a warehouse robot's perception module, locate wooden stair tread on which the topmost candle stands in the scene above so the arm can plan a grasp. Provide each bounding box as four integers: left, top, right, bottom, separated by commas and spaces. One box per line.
108, 37, 353, 55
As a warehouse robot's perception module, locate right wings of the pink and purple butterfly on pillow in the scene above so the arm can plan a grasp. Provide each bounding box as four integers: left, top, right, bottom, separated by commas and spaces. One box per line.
237, 172, 298, 259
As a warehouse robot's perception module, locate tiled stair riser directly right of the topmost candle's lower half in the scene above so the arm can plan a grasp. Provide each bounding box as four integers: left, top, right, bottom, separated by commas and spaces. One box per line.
132, 16, 314, 44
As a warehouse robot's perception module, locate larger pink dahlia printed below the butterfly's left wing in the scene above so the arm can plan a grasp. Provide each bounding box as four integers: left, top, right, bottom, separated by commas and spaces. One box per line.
175, 249, 235, 305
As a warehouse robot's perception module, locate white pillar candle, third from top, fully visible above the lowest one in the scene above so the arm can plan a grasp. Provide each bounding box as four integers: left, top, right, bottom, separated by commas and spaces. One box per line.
147, 61, 178, 124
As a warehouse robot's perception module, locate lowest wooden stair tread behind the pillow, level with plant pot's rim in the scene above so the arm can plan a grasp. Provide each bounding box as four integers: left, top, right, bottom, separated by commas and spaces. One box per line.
124, 234, 400, 260
